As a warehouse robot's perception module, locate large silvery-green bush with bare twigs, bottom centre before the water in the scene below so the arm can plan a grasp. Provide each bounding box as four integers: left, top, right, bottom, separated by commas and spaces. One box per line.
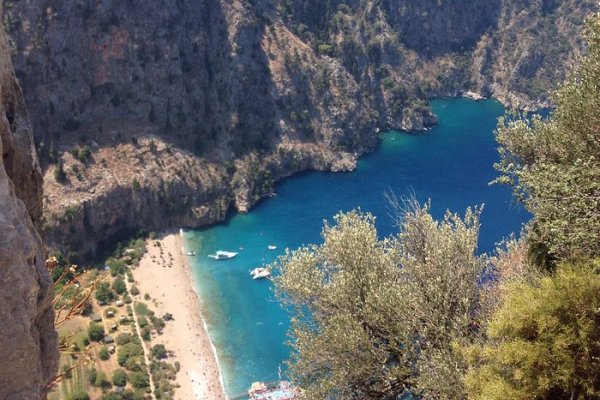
273, 203, 486, 399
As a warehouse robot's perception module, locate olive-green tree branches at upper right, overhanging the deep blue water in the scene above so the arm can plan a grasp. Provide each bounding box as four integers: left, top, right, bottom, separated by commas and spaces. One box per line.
495, 15, 600, 260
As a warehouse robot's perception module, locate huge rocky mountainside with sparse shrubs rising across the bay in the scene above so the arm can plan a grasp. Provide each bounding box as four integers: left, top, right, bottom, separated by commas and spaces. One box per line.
4, 0, 597, 253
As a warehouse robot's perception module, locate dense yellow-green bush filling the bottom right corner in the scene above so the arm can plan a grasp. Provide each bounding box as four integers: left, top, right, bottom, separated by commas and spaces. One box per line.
466, 262, 600, 400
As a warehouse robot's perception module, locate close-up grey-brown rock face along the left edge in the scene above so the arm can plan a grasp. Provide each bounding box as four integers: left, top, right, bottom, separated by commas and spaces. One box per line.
0, 5, 58, 400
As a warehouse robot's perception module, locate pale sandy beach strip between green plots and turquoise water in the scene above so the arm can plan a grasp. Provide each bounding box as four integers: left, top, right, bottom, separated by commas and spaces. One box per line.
133, 232, 226, 400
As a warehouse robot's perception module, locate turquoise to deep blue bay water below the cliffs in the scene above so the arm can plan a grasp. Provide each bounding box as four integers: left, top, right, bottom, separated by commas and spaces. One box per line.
184, 99, 529, 396
